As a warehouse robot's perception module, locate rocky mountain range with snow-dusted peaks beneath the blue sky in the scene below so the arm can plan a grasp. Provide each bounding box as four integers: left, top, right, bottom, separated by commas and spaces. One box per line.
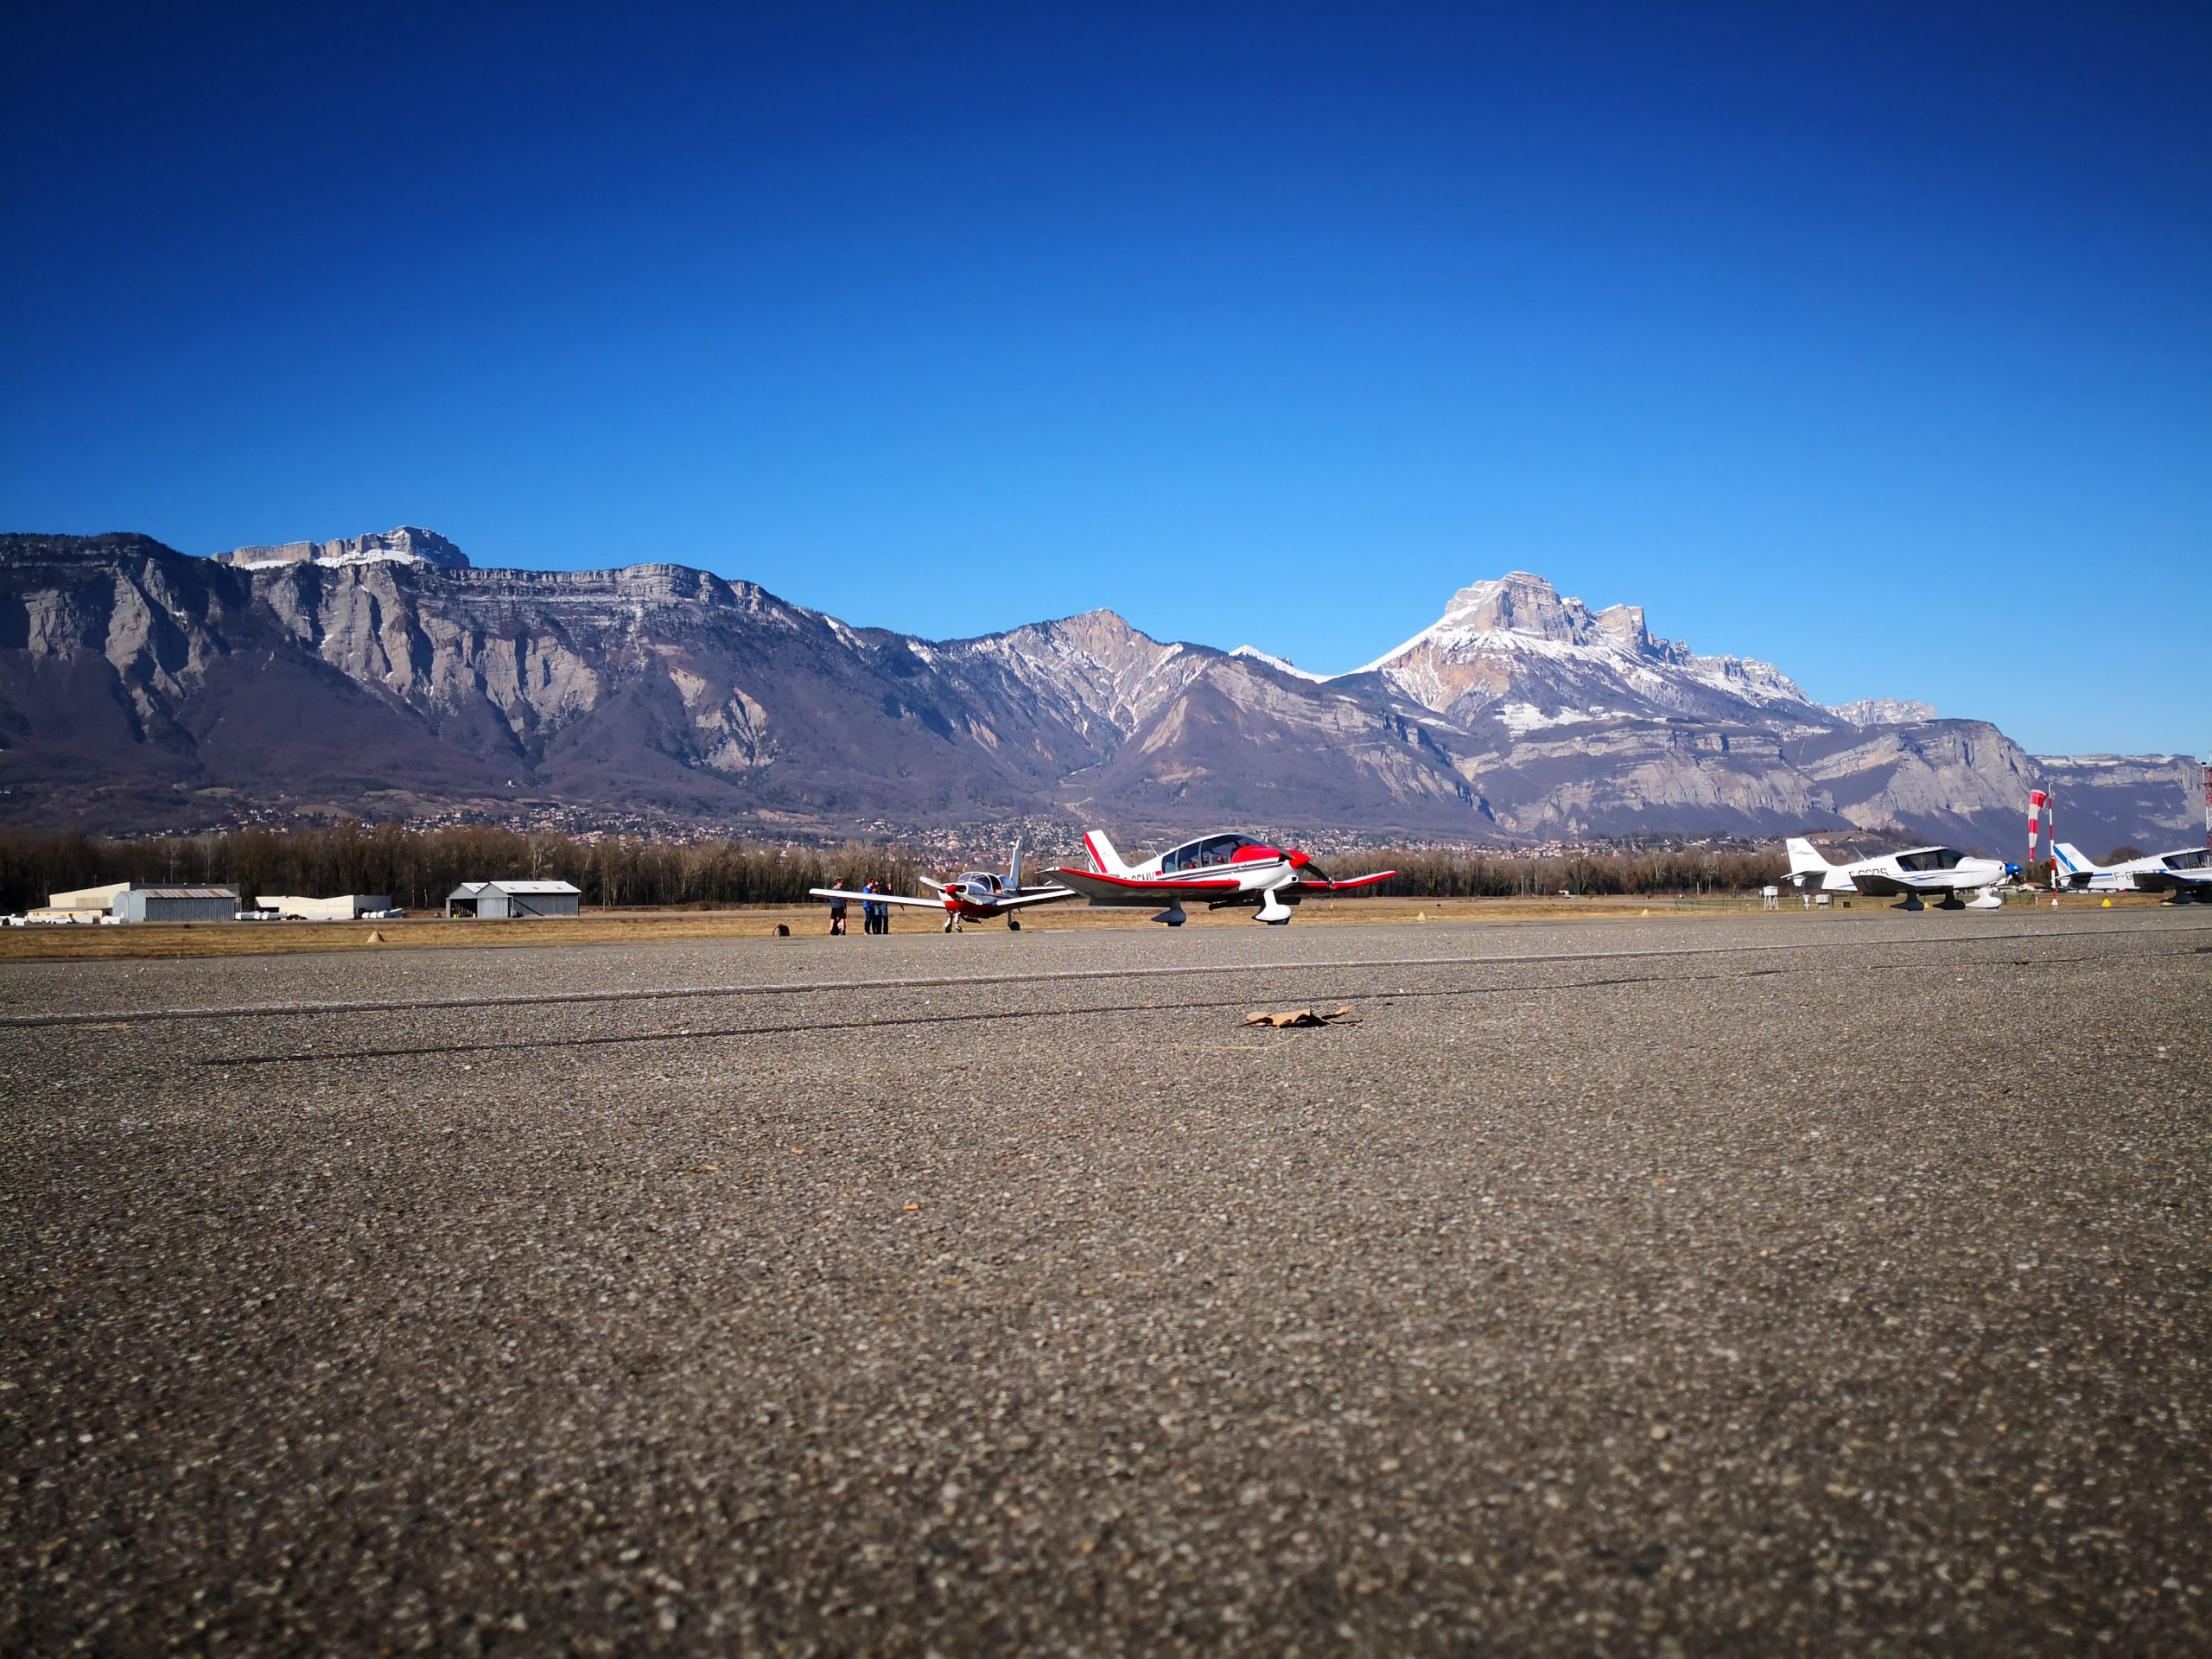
0, 526, 2195, 849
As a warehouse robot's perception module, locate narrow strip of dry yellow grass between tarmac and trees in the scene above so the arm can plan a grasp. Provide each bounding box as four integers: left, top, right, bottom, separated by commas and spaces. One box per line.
0, 893, 2159, 963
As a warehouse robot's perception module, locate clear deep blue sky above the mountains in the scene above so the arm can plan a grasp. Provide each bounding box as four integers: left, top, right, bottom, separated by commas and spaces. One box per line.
0, 4, 2212, 752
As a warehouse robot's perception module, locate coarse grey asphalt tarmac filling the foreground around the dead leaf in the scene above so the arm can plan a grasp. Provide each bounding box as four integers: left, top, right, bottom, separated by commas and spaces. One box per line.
0, 909, 2212, 1655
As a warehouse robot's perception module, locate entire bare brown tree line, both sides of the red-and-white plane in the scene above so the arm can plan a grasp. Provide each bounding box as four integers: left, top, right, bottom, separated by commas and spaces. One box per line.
0, 823, 1785, 912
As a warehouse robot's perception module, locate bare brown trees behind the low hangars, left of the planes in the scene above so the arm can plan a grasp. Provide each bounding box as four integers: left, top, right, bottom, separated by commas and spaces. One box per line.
0, 823, 918, 912
